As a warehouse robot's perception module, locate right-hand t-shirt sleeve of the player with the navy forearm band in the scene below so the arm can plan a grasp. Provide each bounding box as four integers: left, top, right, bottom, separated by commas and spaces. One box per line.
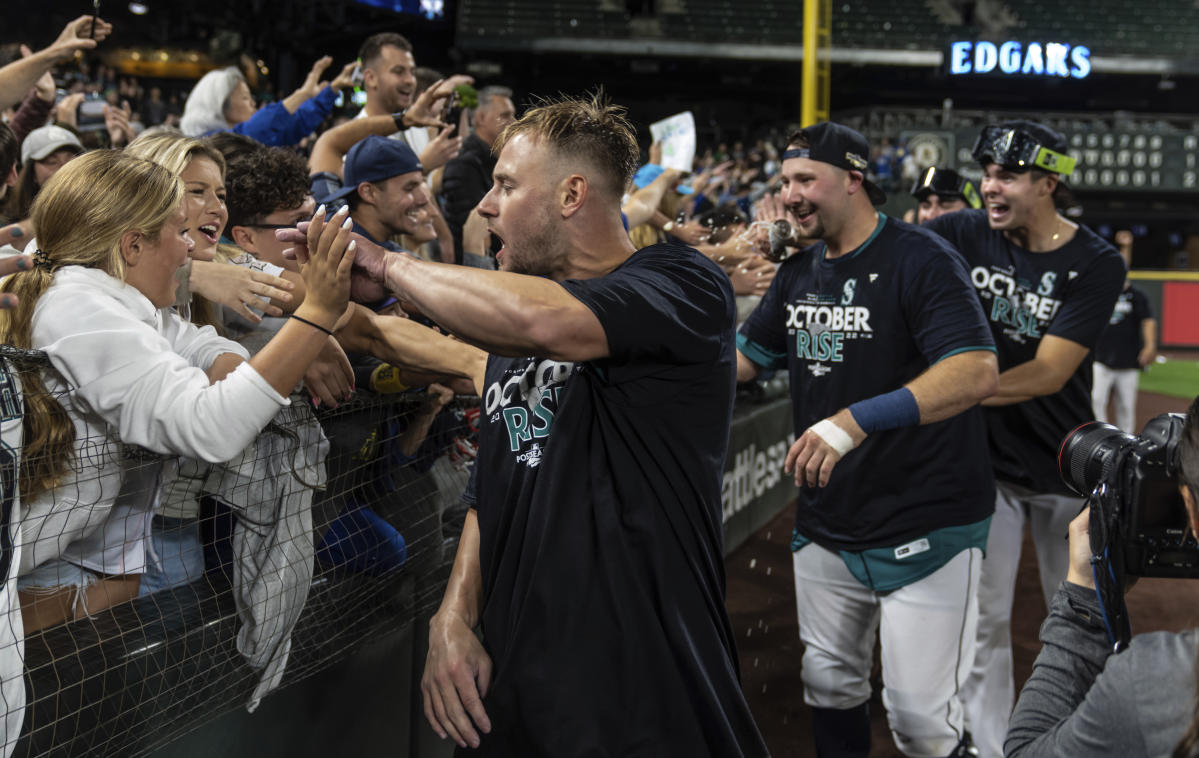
900, 245, 995, 366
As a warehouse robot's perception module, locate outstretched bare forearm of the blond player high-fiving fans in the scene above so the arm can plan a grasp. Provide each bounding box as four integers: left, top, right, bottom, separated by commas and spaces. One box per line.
384, 253, 607, 360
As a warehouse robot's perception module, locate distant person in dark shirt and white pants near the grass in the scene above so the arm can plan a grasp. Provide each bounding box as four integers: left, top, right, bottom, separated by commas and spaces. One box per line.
1091, 229, 1157, 434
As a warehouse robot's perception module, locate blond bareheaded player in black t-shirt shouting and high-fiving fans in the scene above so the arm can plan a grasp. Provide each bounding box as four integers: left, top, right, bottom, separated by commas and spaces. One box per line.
304, 93, 766, 758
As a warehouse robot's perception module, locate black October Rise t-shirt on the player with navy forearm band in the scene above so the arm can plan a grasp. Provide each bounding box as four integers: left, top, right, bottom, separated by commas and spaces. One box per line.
737, 216, 995, 551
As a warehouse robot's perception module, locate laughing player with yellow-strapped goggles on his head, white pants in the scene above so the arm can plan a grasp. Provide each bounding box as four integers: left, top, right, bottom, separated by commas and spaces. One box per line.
928, 121, 1125, 758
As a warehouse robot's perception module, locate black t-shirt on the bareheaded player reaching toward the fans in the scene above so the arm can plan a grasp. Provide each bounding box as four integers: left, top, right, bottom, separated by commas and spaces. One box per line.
469, 245, 766, 758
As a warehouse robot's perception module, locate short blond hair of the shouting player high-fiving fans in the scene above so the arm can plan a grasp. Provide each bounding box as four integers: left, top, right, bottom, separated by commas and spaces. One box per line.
494, 92, 640, 201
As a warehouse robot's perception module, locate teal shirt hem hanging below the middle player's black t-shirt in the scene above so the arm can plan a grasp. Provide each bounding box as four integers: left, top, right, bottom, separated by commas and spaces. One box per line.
791, 516, 992, 592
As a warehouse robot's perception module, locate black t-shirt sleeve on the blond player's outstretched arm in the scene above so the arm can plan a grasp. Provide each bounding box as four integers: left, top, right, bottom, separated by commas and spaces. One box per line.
562, 251, 736, 365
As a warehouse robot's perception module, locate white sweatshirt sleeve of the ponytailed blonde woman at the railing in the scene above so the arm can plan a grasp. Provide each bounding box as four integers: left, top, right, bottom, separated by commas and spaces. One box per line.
34, 290, 288, 463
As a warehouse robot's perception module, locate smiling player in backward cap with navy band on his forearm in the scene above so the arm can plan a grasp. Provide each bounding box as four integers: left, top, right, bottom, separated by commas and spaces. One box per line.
737, 124, 999, 758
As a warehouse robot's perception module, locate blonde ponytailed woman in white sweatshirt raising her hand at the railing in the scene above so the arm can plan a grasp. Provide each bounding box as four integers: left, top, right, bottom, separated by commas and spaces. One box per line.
0, 150, 354, 633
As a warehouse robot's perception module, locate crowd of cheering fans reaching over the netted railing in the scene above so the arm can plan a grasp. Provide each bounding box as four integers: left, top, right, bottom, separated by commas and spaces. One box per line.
0, 11, 1184, 750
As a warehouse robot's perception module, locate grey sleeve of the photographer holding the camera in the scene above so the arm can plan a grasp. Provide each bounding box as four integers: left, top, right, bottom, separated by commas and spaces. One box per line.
1004, 583, 1155, 758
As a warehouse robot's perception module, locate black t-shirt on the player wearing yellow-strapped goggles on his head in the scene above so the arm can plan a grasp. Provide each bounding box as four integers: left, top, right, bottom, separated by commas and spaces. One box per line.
926, 210, 1125, 494
